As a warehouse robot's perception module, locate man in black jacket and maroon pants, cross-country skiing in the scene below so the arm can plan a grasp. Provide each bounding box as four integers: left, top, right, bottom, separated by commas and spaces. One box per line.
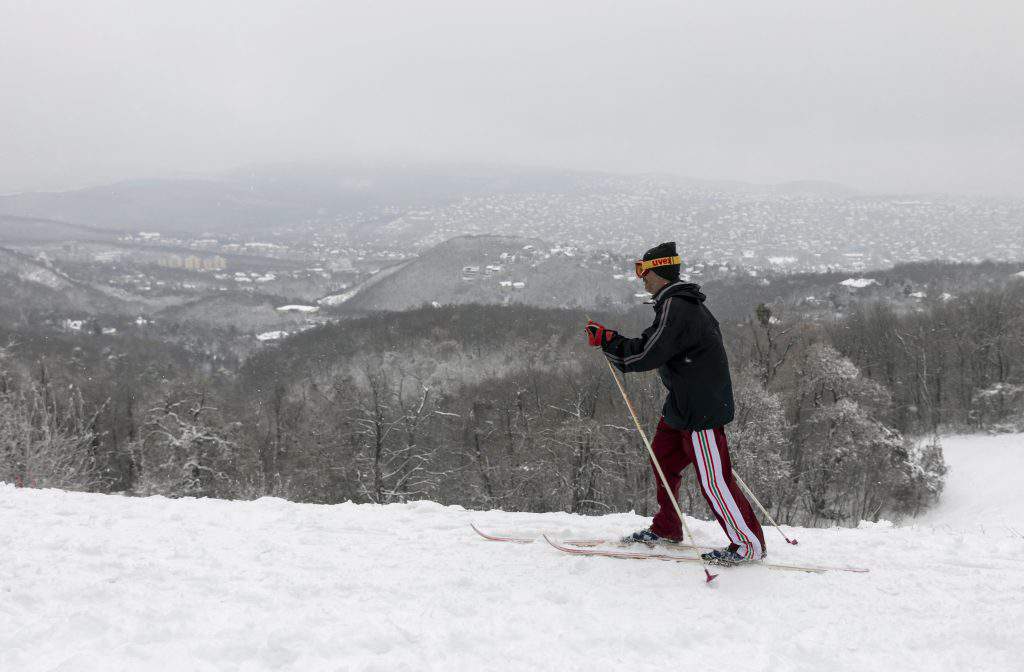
585, 243, 766, 564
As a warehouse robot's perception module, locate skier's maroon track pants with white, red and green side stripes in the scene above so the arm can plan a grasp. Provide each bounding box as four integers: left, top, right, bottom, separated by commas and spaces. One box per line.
651, 418, 765, 558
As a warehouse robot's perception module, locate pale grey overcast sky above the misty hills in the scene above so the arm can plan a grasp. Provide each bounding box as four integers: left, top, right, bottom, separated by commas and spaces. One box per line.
0, 0, 1024, 196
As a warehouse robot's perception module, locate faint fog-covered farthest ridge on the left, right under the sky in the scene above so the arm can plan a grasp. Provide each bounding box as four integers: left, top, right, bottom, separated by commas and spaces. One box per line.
0, 164, 606, 240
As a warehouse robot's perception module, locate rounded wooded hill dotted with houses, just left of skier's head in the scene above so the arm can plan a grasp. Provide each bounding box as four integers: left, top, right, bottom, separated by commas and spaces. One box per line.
340, 236, 643, 311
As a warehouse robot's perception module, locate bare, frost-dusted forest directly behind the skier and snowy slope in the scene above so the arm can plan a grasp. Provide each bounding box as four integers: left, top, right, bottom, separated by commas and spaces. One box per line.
0, 283, 1024, 526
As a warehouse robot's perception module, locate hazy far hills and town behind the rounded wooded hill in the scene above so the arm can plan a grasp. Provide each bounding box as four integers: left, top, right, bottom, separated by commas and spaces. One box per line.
0, 164, 1024, 272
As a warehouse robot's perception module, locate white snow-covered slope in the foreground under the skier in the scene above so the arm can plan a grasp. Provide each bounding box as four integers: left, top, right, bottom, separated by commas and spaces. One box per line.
0, 434, 1024, 672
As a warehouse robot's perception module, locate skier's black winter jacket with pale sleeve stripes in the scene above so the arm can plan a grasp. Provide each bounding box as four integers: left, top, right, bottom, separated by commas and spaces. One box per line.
602, 282, 734, 431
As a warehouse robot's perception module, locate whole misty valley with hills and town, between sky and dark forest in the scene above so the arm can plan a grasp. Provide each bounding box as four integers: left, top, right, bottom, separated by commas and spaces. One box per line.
0, 164, 1024, 329
